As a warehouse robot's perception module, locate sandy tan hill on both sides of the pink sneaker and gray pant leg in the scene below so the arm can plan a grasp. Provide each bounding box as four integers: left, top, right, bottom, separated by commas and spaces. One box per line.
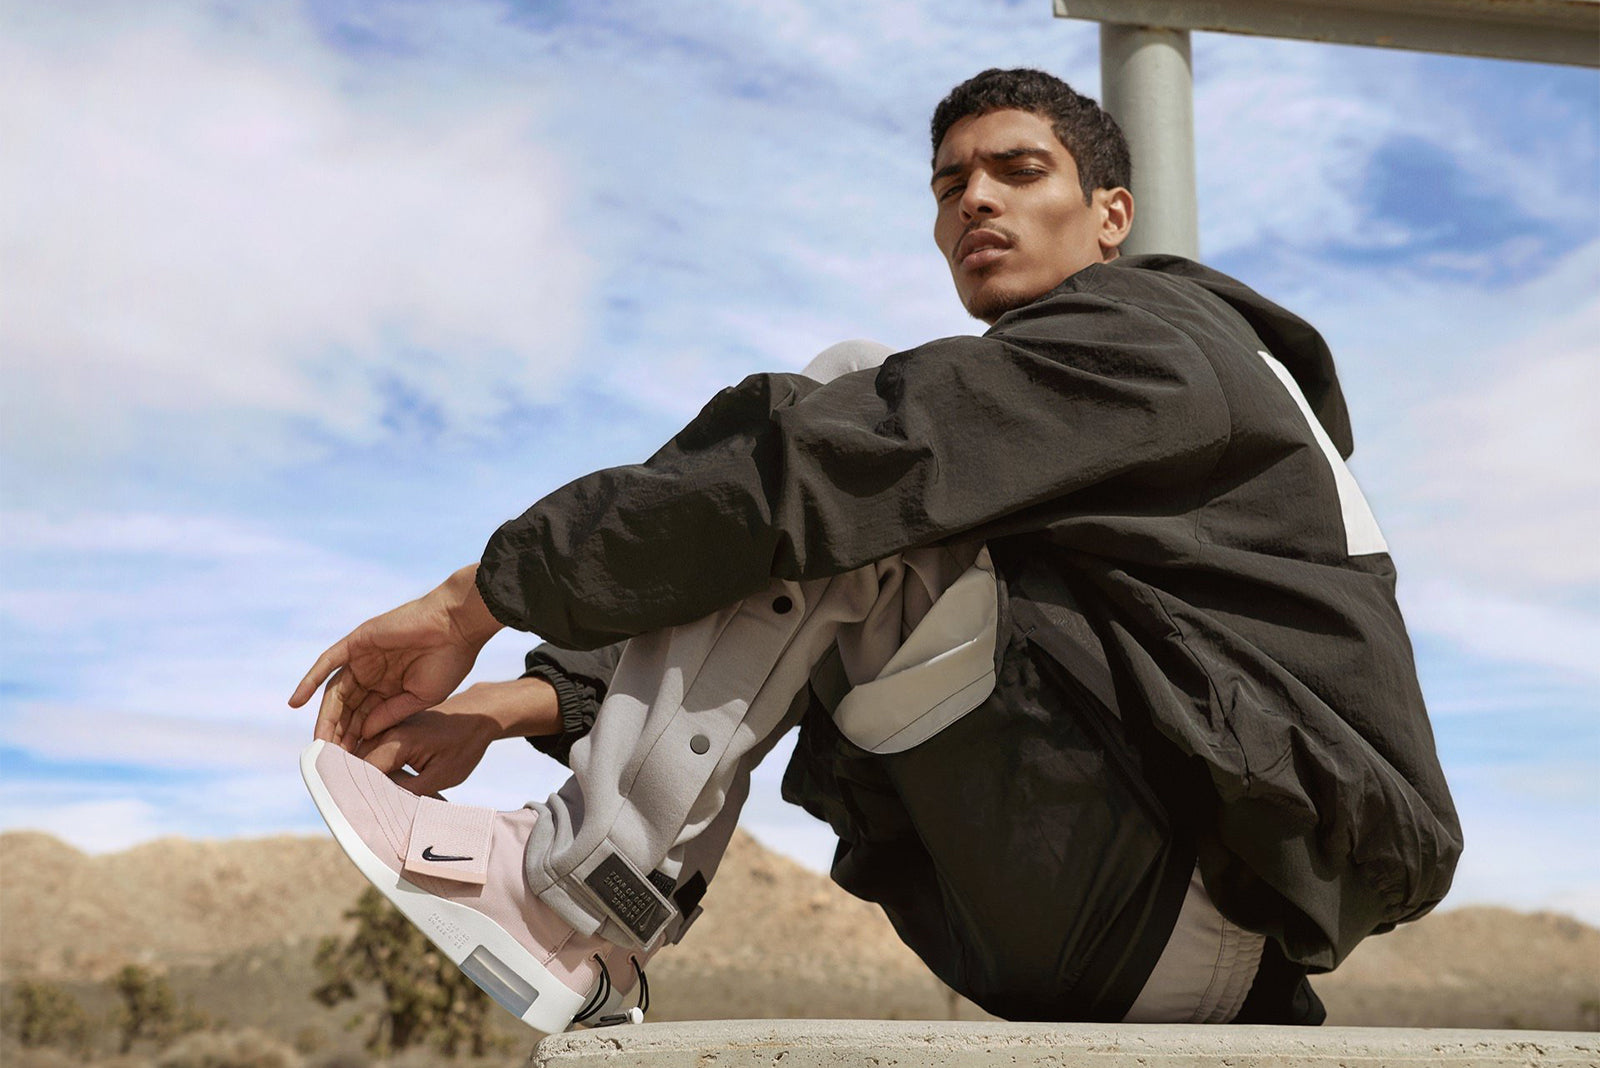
0, 831, 981, 1025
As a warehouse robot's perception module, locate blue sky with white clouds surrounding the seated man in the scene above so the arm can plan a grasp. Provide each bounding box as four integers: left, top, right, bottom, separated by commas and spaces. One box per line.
0, 0, 1600, 923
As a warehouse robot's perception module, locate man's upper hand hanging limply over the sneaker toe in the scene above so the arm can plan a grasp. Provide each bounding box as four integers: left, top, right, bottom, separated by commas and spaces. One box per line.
290, 564, 501, 753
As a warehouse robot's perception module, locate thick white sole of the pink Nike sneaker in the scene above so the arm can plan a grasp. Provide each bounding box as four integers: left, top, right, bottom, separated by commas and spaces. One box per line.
301, 740, 587, 1034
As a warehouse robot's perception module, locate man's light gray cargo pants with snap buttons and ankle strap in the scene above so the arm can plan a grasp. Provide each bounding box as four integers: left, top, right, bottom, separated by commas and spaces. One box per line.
525, 342, 1262, 1022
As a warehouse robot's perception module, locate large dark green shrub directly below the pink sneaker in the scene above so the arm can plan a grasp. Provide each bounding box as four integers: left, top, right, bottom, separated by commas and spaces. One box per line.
312, 887, 506, 1057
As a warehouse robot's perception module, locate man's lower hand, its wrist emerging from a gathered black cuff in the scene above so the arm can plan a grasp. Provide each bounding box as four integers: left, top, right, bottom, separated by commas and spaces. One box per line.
354, 678, 562, 793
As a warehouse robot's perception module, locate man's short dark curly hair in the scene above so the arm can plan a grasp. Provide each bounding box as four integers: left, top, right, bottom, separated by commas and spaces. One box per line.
933, 67, 1133, 203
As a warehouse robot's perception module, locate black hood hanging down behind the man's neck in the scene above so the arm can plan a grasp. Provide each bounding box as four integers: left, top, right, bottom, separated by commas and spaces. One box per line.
1109, 254, 1355, 459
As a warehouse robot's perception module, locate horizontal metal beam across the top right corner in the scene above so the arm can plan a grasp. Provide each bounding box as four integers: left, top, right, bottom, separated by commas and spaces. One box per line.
1053, 0, 1600, 67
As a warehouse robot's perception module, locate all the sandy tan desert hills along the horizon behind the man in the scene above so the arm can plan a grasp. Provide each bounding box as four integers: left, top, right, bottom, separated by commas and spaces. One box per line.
0, 833, 1600, 1028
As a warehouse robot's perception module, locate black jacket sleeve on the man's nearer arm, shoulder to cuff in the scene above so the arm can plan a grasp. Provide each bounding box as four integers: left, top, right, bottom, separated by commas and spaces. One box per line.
478, 293, 1229, 649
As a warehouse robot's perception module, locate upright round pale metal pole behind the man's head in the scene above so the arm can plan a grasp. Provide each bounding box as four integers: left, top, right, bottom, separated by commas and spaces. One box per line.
1101, 22, 1200, 259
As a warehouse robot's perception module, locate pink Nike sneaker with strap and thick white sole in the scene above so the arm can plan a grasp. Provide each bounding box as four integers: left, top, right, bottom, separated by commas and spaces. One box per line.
301, 740, 650, 1034
